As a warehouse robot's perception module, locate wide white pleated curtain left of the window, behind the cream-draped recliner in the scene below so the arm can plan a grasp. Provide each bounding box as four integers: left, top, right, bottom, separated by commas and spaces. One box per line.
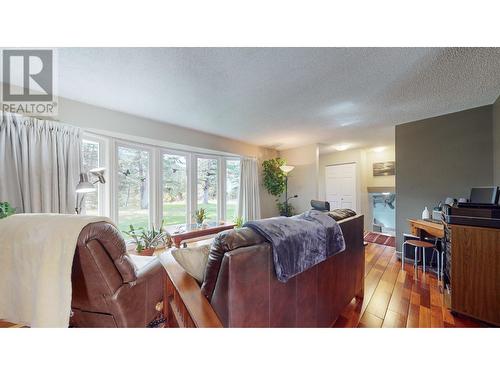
0, 112, 81, 213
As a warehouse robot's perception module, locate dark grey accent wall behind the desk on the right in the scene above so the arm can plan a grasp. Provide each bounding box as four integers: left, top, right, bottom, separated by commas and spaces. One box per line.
396, 105, 493, 246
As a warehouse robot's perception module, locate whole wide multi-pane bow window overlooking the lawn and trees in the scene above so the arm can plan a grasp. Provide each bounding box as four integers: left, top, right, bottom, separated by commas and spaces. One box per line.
88, 133, 244, 232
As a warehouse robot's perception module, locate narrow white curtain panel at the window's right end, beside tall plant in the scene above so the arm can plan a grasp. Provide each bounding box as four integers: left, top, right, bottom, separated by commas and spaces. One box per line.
238, 158, 260, 221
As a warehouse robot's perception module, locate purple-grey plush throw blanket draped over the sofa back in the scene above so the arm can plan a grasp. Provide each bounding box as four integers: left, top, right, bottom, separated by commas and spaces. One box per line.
244, 211, 345, 282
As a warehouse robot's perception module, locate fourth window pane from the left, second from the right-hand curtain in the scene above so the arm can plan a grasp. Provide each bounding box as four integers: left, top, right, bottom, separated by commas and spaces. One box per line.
196, 157, 219, 221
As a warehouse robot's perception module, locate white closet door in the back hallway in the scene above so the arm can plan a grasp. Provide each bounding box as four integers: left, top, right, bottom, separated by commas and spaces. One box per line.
325, 163, 356, 211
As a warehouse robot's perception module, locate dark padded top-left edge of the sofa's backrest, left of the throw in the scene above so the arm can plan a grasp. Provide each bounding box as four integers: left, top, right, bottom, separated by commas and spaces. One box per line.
201, 228, 265, 300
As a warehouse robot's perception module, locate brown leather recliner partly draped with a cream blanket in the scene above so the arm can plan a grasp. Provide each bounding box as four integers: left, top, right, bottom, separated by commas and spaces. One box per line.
70, 222, 164, 327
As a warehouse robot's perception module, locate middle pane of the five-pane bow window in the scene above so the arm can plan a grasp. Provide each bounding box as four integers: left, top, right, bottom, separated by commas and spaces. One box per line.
162, 153, 188, 226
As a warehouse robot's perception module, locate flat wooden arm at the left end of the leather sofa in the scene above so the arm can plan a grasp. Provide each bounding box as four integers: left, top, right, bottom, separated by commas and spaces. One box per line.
160, 252, 222, 328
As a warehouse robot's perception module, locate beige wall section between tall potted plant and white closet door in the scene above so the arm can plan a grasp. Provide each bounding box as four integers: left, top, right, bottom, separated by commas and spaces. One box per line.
280, 144, 319, 213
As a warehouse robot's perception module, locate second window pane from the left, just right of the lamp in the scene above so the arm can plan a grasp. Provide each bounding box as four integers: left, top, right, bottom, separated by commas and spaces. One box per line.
117, 146, 150, 231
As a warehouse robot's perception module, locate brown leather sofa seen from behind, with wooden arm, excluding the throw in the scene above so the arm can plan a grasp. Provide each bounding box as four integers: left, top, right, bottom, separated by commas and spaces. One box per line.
163, 215, 365, 327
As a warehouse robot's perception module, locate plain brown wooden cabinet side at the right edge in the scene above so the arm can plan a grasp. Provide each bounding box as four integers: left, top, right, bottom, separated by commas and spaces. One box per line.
448, 225, 500, 326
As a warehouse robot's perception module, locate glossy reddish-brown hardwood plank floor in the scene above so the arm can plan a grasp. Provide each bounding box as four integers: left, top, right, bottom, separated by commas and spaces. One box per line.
0, 243, 488, 328
